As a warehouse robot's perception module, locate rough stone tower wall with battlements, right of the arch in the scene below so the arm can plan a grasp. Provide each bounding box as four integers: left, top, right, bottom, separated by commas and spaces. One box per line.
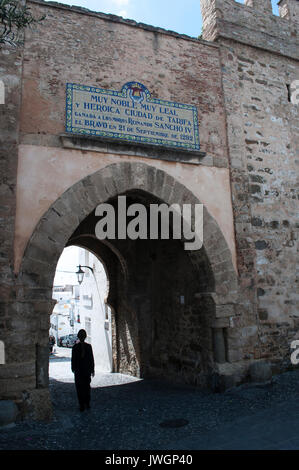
202, 0, 299, 365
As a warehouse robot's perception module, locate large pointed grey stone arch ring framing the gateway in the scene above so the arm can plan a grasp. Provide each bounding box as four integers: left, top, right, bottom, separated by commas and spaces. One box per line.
17, 161, 238, 415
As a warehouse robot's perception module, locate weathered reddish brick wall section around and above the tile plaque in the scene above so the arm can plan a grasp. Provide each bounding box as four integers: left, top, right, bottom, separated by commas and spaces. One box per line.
21, 0, 227, 167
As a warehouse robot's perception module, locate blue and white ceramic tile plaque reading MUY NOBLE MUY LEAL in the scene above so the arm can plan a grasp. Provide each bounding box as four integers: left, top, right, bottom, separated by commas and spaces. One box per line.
66, 82, 200, 151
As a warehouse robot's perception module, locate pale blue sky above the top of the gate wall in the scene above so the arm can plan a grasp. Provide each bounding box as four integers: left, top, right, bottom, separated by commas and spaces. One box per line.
44, 0, 278, 37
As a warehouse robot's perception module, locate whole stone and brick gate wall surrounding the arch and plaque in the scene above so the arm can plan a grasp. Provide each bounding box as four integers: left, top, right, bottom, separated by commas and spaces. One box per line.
0, 0, 299, 417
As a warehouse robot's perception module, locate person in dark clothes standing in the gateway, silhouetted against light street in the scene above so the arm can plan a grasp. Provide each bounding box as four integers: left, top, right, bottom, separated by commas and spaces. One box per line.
72, 330, 94, 411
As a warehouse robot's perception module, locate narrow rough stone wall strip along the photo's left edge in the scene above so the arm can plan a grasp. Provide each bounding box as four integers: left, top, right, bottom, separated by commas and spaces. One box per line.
0, 0, 31, 418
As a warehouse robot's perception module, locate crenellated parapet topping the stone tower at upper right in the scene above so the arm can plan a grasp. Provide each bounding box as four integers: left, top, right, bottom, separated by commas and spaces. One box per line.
200, 0, 299, 60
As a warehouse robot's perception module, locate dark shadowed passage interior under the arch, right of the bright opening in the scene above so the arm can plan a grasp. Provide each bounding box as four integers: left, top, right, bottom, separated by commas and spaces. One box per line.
68, 191, 213, 385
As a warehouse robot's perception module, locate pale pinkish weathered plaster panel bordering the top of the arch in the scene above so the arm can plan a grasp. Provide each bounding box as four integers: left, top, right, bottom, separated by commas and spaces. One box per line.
14, 145, 236, 272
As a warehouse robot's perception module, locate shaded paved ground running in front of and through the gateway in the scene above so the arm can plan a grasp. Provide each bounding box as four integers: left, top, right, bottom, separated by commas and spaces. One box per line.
0, 348, 299, 451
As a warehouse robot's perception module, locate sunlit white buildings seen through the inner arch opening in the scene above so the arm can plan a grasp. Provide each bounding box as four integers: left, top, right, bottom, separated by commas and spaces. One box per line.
49, 246, 112, 372
